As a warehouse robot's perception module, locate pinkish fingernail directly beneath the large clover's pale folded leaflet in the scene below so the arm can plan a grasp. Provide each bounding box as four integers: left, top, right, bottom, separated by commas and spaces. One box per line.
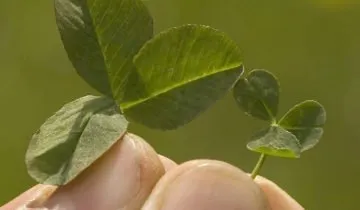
41, 135, 141, 210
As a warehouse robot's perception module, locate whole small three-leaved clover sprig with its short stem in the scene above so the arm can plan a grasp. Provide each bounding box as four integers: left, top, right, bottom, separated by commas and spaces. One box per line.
233, 69, 326, 178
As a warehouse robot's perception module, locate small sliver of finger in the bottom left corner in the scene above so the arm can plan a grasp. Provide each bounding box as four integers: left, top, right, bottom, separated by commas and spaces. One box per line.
0, 184, 56, 210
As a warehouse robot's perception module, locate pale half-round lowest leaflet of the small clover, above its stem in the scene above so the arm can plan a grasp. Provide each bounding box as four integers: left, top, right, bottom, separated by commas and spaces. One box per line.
247, 126, 301, 158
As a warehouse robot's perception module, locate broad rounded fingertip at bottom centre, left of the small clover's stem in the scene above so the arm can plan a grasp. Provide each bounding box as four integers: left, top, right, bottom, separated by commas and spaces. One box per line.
142, 160, 268, 210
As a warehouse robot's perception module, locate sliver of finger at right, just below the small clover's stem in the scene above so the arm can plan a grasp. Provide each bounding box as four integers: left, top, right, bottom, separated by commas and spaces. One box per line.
255, 176, 304, 210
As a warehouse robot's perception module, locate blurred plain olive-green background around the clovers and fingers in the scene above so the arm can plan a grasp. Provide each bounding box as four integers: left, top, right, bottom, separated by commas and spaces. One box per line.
0, 0, 360, 210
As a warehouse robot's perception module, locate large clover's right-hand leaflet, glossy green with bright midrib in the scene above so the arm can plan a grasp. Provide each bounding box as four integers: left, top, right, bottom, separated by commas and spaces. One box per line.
121, 25, 243, 130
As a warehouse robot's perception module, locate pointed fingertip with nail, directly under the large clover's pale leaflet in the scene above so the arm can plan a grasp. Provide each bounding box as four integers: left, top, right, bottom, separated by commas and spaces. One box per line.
25, 134, 165, 210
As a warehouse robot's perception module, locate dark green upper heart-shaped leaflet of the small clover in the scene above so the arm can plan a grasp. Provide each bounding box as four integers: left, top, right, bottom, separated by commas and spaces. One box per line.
233, 70, 280, 121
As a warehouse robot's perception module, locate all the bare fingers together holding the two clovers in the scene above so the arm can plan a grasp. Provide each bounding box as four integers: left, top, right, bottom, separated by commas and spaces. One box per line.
0, 134, 304, 210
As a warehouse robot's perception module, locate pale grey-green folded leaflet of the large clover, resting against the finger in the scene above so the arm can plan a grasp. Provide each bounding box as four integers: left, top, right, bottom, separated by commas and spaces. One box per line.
26, 96, 128, 185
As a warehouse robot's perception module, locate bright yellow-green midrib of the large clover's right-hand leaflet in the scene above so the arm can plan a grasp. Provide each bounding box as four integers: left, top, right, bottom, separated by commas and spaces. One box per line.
120, 62, 242, 111
